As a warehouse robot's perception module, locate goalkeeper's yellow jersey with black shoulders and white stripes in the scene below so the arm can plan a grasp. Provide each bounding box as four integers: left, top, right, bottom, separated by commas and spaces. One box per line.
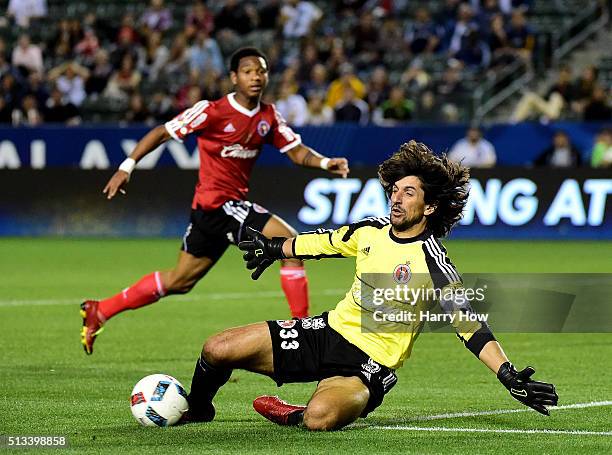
293, 218, 494, 369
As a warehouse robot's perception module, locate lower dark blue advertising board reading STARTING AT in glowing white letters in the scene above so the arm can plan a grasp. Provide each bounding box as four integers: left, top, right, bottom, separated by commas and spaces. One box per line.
0, 166, 612, 240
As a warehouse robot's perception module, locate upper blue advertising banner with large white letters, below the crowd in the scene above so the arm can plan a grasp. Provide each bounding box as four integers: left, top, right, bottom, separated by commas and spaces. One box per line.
0, 123, 604, 169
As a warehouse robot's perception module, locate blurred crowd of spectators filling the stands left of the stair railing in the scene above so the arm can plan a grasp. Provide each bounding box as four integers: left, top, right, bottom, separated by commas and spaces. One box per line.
0, 0, 556, 126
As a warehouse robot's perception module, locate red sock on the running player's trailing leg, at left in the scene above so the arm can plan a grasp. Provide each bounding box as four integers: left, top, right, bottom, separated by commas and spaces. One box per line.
98, 272, 166, 320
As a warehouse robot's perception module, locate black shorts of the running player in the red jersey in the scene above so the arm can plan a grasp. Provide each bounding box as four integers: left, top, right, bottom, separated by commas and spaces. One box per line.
181, 201, 272, 261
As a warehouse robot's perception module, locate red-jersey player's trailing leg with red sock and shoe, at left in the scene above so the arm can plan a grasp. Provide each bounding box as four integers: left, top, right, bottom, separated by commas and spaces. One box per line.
81, 251, 215, 354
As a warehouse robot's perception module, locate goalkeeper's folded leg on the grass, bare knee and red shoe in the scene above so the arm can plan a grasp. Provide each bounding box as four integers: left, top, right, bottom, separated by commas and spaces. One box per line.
253, 376, 370, 431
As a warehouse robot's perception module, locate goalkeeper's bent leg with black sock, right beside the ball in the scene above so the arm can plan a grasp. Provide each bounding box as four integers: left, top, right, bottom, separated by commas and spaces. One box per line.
183, 322, 274, 422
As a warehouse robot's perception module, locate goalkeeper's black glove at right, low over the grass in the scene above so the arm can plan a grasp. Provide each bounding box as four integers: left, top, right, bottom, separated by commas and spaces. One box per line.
497, 362, 559, 415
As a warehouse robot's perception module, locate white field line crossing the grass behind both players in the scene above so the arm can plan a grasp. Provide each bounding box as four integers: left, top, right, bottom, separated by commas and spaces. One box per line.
0, 289, 346, 307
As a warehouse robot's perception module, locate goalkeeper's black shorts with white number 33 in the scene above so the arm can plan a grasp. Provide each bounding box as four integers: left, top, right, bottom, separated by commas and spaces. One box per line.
268, 313, 397, 417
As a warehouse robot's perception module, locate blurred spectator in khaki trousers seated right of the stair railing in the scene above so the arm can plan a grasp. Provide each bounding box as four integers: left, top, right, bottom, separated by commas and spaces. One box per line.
512, 66, 574, 123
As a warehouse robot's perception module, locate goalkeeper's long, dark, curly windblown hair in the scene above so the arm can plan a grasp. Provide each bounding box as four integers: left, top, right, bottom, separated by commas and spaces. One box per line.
378, 141, 470, 237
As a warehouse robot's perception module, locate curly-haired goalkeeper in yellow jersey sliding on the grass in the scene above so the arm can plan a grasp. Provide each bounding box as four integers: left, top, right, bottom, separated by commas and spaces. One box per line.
184, 141, 558, 430
